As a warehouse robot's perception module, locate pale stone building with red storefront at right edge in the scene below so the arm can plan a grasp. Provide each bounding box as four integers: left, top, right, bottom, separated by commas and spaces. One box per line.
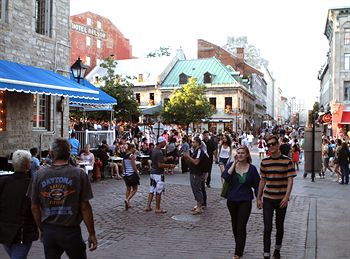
318, 7, 350, 137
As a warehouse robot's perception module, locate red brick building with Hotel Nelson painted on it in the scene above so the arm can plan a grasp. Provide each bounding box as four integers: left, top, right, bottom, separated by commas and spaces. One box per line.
70, 12, 132, 72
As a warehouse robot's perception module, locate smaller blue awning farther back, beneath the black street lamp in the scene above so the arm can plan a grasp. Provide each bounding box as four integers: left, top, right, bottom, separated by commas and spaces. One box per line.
69, 74, 117, 110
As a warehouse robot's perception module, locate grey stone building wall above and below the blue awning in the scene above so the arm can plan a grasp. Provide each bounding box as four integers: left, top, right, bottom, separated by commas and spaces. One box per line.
0, 0, 70, 156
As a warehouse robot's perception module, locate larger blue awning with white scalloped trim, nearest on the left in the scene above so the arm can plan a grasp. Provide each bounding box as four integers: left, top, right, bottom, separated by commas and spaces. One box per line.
0, 60, 99, 100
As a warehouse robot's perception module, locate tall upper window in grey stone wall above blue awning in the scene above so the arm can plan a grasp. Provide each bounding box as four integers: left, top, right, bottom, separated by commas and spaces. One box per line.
35, 0, 52, 37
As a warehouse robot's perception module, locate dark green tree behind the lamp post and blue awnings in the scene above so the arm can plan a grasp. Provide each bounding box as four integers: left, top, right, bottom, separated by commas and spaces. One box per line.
100, 57, 140, 121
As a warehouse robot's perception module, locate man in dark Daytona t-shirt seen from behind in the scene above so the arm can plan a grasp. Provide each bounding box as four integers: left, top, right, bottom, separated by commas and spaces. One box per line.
27, 138, 97, 259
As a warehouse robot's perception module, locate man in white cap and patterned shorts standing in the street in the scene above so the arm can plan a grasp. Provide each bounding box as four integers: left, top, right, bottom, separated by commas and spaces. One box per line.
145, 136, 175, 213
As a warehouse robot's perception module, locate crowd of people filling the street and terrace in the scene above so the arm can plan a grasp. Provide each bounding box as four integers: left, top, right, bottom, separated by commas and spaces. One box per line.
0, 122, 336, 259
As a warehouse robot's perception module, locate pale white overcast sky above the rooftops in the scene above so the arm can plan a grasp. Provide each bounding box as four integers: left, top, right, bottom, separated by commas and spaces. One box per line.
70, 0, 350, 106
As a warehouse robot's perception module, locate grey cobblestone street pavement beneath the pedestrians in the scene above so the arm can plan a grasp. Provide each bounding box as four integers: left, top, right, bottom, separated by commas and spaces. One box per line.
0, 149, 350, 259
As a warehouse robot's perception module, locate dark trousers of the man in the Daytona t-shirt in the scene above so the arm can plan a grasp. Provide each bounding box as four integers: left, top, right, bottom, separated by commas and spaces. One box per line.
43, 224, 86, 259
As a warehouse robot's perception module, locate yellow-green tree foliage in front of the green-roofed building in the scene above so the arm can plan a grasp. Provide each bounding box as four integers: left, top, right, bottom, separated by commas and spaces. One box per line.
161, 78, 213, 128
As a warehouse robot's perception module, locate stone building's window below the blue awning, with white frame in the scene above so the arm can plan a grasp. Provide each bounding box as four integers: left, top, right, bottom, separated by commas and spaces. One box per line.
33, 94, 50, 129
